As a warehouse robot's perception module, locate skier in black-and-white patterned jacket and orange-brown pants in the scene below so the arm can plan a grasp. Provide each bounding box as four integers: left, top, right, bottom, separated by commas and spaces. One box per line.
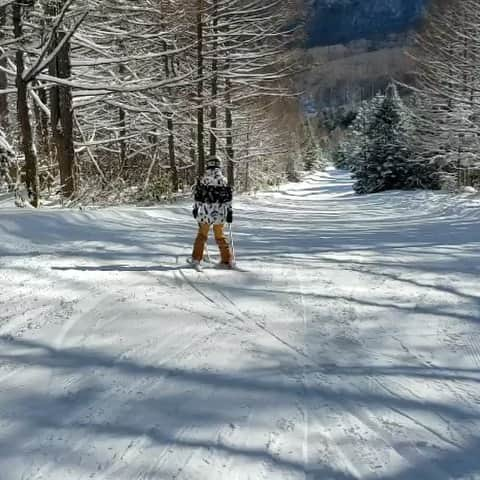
192, 156, 233, 268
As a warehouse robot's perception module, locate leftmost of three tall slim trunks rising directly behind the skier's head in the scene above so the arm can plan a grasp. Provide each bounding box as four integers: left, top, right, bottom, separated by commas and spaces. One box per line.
197, 0, 205, 177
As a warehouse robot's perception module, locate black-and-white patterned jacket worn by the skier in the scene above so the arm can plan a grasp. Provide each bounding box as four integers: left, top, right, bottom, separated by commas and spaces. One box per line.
193, 168, 232, 225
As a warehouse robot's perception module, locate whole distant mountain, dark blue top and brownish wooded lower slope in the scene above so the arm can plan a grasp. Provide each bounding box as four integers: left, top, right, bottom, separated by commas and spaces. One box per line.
302, 0, 429, 110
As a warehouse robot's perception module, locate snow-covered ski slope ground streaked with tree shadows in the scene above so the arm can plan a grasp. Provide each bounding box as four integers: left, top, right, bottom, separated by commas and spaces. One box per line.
0, 171, 480, 480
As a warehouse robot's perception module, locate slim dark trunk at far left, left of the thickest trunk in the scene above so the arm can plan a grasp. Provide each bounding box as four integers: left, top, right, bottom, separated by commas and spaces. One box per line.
12, 1, 40, 207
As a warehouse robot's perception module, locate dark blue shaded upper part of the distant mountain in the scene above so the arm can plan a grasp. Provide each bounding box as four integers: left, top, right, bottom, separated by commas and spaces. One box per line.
307, 0, 428, 47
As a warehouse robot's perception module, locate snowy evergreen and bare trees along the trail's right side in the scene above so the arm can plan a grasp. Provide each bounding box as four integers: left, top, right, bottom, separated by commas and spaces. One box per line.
334, 0, 480, 193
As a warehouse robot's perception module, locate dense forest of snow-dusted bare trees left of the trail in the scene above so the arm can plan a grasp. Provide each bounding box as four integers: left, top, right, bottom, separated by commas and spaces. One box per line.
0, 0, 314, 206
